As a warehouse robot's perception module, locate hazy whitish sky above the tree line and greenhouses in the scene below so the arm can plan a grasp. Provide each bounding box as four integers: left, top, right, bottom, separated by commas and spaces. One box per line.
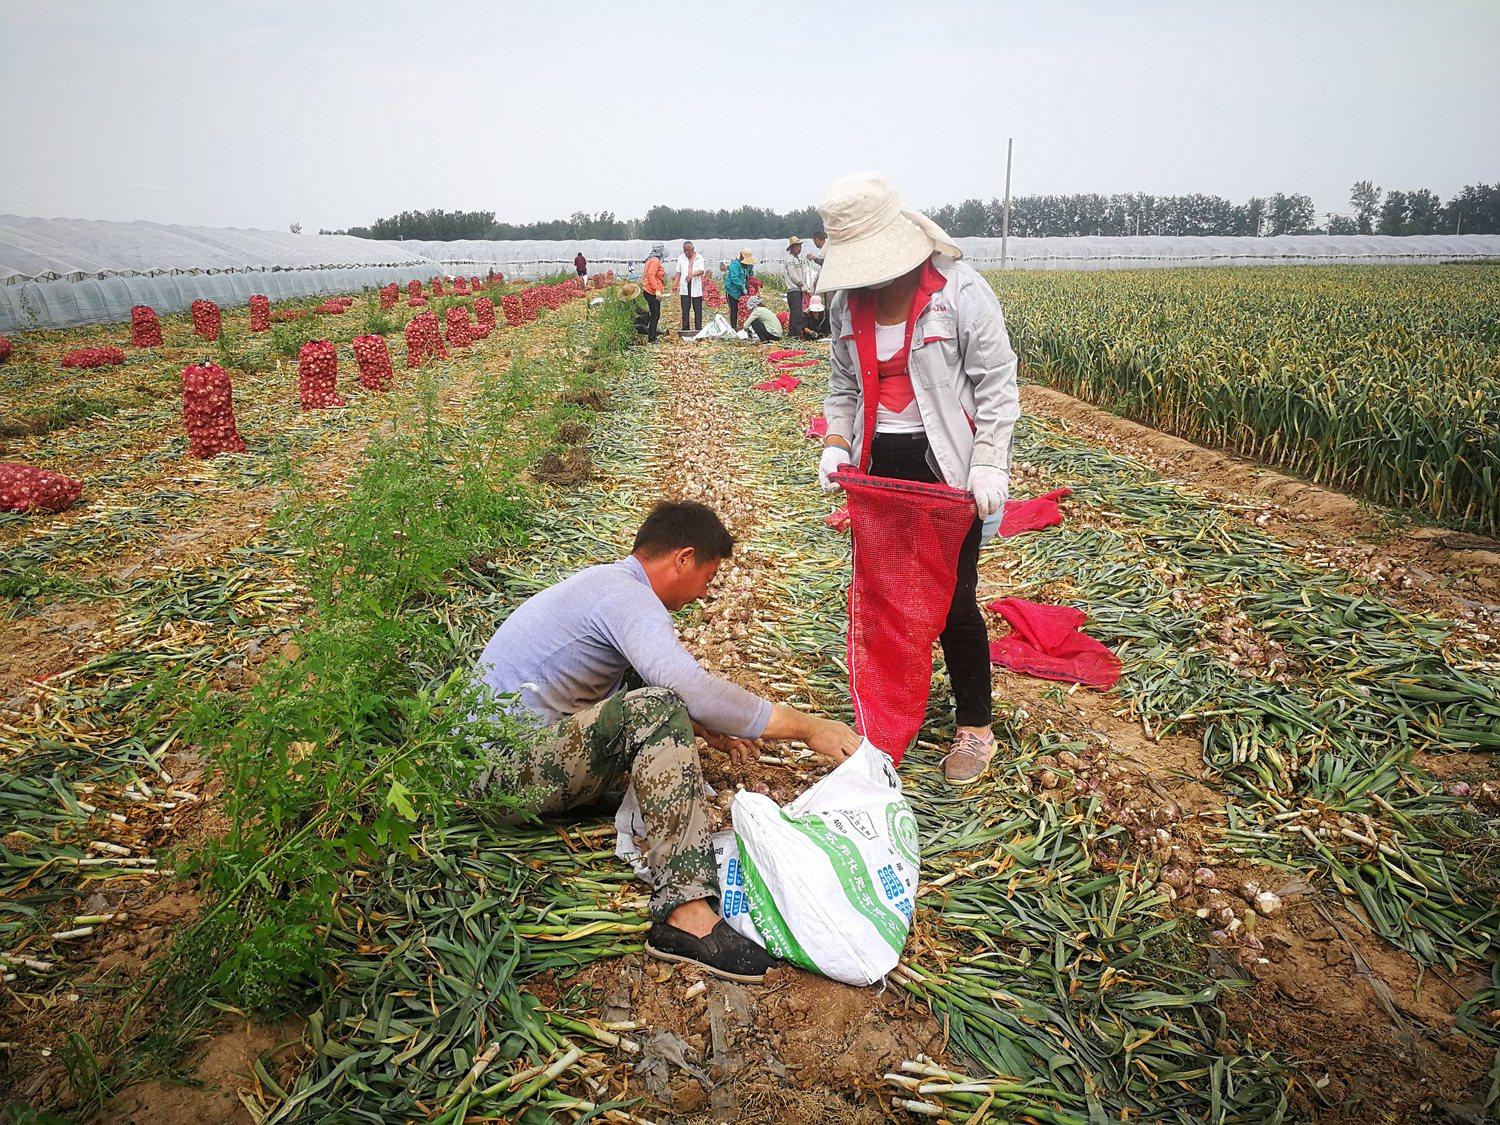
0, 0, 1500, 231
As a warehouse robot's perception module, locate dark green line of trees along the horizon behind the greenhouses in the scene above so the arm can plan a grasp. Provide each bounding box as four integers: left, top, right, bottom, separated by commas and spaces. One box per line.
320, 180, 1500, 242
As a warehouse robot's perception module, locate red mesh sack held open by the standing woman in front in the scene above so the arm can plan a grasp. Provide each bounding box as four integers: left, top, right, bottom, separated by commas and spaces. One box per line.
834, 470, 975, 765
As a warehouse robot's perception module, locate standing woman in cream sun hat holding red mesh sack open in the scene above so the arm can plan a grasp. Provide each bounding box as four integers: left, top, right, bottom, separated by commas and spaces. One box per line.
818, 173, 1020, 785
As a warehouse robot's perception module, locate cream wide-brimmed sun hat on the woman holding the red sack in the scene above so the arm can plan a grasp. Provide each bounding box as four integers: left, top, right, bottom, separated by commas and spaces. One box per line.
818, 173, 963, 293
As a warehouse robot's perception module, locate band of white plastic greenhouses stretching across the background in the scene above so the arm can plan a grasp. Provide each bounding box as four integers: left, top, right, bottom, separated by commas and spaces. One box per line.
0, 215, 1500, 333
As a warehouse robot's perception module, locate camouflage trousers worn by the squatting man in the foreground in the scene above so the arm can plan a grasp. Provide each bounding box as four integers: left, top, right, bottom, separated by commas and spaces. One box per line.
498, 687, 719, 921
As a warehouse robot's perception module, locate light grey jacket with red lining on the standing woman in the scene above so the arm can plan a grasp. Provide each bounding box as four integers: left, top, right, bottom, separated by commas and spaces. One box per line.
824, 258, 1022, 489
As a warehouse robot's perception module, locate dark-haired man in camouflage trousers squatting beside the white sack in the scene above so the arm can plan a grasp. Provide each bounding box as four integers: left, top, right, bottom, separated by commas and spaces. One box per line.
480, 501, 860, 981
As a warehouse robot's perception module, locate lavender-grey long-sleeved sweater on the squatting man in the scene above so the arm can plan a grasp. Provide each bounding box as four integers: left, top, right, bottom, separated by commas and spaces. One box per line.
479, 555, 771, 738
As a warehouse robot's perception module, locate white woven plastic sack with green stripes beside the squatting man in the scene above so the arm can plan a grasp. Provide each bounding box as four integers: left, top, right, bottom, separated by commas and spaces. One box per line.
720, 743, 921, 984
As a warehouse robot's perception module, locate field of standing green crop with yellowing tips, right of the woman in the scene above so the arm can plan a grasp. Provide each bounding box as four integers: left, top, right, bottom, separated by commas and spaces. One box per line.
993, 266, 1500, 536
